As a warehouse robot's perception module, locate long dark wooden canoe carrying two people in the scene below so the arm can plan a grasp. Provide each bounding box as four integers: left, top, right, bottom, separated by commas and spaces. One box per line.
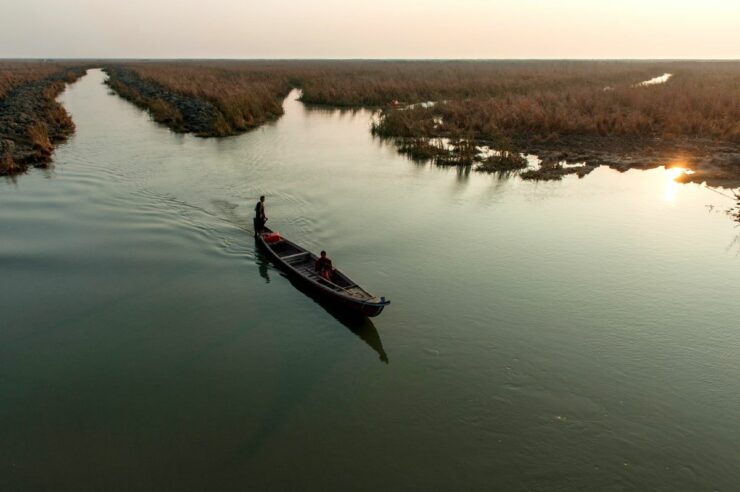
256, 227, 391, 317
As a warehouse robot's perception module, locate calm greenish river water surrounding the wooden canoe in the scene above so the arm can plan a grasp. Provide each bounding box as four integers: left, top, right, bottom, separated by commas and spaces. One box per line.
0, 71, 740, 490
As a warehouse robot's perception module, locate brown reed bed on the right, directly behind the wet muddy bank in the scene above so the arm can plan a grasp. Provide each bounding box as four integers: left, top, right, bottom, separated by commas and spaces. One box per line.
364, 62, 740, 143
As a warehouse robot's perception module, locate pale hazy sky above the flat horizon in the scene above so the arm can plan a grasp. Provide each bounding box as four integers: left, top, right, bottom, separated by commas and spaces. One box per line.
0, 0, 740, 58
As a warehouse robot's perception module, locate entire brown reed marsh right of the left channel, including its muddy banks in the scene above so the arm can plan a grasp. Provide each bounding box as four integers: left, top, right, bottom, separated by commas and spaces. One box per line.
105, 60, 740, 182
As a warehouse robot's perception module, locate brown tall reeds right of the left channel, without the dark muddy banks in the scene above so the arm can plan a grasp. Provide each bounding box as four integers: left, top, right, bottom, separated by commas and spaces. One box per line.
111, 61, 740, 143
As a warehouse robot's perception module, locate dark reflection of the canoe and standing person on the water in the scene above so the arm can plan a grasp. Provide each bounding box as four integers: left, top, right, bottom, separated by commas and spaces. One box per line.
255, 248, 389, 364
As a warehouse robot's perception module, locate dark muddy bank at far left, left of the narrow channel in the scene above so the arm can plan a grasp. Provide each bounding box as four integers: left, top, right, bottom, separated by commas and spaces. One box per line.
0, 67, 86, 175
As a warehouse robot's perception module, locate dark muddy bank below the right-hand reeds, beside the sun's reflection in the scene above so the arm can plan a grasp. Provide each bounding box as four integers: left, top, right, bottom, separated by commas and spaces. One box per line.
374, 132, 740, 188
